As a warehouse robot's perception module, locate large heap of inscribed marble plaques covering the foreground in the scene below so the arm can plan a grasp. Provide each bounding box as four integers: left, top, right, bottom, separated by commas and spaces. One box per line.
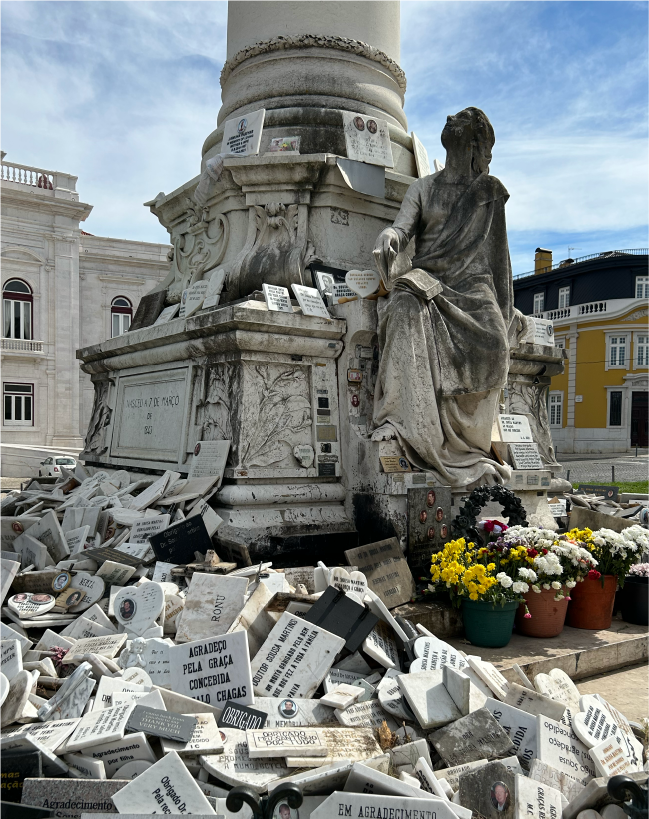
0, 468, 647, 819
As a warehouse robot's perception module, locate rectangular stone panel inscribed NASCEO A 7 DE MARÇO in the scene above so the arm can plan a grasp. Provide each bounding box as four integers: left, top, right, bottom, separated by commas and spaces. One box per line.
111, 367, 189, 461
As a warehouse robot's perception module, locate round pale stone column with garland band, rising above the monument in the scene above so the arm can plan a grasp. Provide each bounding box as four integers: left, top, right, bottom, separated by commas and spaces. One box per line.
203, 0, 416, 176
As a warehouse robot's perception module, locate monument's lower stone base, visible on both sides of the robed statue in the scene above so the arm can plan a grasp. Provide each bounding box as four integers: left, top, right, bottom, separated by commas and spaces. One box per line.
79, 297, 563, 565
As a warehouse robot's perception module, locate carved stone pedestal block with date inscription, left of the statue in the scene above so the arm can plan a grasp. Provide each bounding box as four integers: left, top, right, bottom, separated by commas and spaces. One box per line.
79, 299, 358, 563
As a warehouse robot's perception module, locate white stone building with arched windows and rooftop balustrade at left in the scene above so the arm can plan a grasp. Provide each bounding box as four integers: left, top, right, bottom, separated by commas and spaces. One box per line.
0, 155, 171, 450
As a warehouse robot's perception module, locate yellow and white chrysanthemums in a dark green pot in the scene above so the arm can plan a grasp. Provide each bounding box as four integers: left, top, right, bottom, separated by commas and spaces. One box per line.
429, 538, 529, 647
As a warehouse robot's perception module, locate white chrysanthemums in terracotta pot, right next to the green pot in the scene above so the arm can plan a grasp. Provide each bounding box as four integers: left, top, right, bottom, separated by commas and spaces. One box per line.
504, 526, 597, 637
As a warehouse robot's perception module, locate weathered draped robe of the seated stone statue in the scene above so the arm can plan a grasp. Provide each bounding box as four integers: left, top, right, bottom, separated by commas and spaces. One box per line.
374, 169, 514, 486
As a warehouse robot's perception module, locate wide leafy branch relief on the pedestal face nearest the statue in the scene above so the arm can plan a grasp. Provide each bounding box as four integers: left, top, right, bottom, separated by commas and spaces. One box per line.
240, 364, 313, 466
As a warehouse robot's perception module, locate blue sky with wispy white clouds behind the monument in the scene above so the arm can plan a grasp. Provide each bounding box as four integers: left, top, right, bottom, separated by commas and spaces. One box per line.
0, 0, 649, 275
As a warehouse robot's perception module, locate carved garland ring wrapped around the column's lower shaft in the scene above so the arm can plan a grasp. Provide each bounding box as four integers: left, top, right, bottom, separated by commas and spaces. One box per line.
221, 34, 406, 92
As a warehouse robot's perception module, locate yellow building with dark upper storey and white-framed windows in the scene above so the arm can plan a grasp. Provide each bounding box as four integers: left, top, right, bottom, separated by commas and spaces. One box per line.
514, 248, 649, 453
